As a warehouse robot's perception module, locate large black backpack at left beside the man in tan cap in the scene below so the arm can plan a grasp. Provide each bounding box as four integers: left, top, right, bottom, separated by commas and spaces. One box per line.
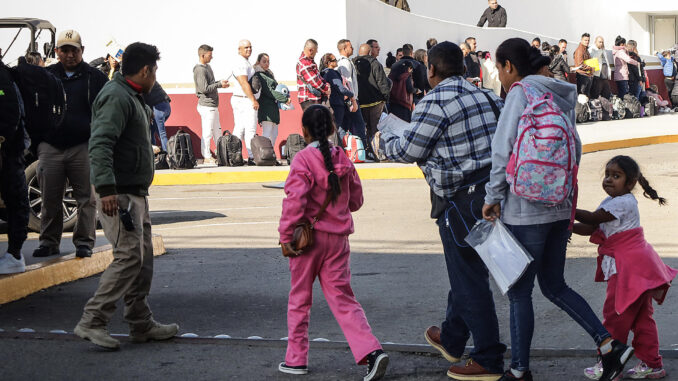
14, 57, 66, 138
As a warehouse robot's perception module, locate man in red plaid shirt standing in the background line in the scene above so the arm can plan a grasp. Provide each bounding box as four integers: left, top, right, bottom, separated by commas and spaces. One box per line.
297, 39, 330, 110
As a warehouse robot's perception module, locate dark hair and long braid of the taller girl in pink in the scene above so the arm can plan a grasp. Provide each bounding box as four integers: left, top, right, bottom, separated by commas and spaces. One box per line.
301, 105, 341, 202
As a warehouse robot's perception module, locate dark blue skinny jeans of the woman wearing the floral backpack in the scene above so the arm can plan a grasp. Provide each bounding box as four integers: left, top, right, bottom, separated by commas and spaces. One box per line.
507, 220, 610, 371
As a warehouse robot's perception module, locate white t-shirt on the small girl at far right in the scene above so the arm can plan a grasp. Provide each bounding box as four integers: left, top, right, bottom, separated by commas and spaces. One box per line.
598, 193, 640, 280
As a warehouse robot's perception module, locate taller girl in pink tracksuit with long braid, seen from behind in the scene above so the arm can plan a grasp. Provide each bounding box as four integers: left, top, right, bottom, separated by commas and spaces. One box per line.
278, 105, 388, 380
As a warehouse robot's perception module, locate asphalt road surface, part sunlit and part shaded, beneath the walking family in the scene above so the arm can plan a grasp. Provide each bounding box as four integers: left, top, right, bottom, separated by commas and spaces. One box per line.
0, 144, 678, 380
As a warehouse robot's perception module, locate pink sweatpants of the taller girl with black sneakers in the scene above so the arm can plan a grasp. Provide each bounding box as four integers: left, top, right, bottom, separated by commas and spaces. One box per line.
285, 231, 381, 366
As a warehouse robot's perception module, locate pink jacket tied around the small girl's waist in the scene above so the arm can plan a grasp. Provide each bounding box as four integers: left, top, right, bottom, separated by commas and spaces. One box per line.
590, 228, 678, 314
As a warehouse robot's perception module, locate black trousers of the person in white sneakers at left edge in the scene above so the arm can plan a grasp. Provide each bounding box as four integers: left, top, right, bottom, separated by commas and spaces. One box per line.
0, 149, 29, 254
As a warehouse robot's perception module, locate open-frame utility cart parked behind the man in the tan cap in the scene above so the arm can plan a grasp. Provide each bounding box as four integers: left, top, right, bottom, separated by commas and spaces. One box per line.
0, 17, 77, 232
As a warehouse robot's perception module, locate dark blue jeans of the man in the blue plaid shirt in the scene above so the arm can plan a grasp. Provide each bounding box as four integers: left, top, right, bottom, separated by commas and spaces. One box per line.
437, 184, 506, 373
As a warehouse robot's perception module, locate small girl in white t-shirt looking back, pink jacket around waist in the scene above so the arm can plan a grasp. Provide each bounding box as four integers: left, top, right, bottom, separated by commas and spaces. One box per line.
574, 156, 678, 379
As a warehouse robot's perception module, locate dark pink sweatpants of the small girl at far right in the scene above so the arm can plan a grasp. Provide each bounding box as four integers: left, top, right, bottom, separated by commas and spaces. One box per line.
603, 275, 663, 368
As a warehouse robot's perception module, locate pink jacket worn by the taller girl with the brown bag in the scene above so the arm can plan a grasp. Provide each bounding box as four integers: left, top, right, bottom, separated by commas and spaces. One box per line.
278, 146, 363, 243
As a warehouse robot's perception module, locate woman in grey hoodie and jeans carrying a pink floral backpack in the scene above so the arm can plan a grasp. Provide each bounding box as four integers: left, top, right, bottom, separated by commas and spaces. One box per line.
482, 38, 633, 381
